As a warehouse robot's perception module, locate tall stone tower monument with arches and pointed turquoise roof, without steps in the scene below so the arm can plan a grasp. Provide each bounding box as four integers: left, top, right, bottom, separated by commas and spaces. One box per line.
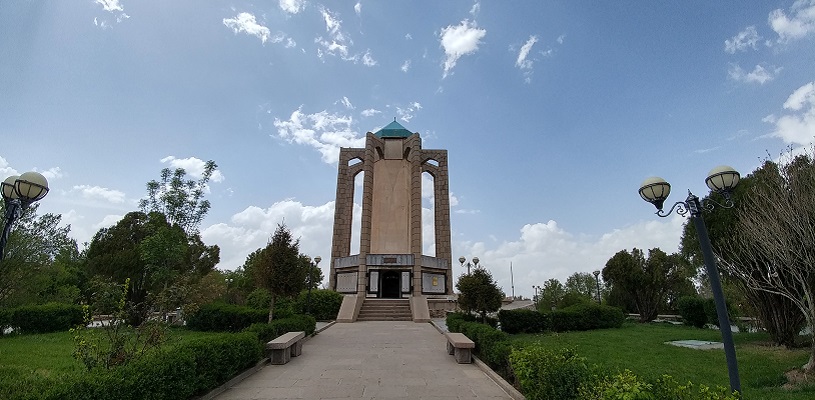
329, 121, 453, 306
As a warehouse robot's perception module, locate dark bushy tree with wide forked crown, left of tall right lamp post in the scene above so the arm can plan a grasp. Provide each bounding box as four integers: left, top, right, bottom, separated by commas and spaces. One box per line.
603, 248, 690, 322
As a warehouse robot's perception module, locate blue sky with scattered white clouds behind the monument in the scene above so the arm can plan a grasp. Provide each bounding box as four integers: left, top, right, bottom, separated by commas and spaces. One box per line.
0, 0, 815, 296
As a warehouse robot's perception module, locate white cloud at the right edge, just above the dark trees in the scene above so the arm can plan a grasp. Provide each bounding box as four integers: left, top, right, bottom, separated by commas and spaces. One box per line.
763, 82, 815, 146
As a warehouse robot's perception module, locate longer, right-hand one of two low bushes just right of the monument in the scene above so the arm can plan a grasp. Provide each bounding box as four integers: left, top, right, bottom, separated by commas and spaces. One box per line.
550, 303, 625, 332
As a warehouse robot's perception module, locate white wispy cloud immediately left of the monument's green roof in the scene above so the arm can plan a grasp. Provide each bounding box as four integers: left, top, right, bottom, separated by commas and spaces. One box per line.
274, 106, 365, 164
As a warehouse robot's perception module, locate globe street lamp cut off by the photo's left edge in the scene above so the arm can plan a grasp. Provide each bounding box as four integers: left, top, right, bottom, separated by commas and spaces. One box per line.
0, 171, 48, 260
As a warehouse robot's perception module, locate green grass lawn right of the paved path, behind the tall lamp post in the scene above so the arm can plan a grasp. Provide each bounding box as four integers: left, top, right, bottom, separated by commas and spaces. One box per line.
512, 323, 815, 400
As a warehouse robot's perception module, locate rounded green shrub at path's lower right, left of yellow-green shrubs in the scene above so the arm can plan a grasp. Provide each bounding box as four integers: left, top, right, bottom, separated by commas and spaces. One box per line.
509, 344, 591, 400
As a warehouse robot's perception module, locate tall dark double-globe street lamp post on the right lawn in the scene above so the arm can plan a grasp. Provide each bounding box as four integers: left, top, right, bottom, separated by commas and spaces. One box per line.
640, 165, 741, 393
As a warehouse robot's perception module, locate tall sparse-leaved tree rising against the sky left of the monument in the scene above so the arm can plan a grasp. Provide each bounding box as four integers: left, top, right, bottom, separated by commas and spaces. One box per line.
139, 160, 218, 234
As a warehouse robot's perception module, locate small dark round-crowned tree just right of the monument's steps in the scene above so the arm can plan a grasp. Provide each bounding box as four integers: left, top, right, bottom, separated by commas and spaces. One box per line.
456, 266, 504, 322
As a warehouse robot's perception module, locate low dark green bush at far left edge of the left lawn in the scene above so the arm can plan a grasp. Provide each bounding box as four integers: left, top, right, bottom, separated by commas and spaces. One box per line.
9, 303, 84, 333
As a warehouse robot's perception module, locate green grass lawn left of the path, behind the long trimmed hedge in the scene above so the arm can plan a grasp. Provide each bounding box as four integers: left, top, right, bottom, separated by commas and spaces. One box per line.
0, 329, 223, 397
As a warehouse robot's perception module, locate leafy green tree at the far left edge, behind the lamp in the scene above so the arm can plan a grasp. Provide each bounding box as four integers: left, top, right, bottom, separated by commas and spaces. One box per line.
0, 202, 80, 307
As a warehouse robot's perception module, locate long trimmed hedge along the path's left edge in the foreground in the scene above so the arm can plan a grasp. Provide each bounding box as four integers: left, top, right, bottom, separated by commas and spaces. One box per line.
3, 333, 262, 400
